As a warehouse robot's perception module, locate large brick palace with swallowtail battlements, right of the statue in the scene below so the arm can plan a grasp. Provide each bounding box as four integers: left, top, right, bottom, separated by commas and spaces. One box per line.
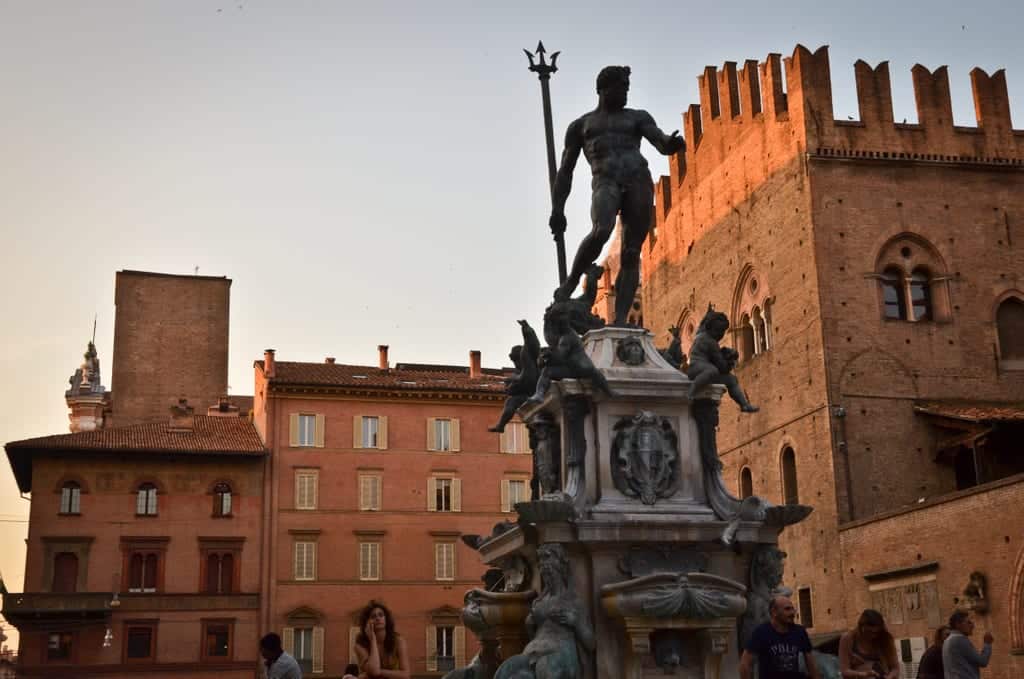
642, 46, 1024, 679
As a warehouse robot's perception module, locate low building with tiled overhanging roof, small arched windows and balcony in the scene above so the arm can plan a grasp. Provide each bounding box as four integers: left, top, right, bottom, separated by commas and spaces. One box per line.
3, 395, 266, 679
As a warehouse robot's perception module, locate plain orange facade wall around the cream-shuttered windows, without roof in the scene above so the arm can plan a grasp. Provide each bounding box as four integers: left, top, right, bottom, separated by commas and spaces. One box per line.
260, 378, 531, 676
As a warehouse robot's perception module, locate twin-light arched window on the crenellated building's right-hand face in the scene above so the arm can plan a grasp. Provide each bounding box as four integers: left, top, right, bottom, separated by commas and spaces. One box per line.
874, 234, 950, 323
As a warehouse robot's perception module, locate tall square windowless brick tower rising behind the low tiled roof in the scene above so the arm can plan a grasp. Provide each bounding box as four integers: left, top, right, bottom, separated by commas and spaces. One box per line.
111, 270, 231, 425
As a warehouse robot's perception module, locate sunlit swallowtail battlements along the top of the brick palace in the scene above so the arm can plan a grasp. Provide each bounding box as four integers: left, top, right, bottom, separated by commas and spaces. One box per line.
655, 45, 1024, 264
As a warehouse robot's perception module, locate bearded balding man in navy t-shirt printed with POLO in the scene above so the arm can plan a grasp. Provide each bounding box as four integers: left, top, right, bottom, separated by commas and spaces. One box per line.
739, 596, 821, 679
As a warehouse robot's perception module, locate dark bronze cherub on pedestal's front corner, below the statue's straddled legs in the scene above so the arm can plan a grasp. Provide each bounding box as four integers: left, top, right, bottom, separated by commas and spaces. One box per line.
528, 302, 613, 404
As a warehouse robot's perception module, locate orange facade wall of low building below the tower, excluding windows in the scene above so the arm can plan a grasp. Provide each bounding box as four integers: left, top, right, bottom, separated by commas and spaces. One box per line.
19, 453, 263, 678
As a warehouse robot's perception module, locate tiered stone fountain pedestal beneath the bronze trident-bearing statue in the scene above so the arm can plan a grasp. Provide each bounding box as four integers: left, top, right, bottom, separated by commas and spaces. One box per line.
464, 328, 810, 679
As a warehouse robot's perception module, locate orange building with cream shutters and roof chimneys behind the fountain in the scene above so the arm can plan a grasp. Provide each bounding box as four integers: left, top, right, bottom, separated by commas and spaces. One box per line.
253, 346, 531, 677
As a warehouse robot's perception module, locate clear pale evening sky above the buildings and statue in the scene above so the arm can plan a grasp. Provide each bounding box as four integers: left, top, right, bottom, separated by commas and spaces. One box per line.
0, 0, 1024, 647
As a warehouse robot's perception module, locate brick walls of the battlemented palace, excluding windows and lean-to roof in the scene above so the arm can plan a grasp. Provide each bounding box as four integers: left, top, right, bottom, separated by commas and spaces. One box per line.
642, 47, 1024, 659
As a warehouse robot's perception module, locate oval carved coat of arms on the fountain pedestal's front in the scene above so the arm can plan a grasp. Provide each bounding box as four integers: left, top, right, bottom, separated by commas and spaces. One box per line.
611, 411, 679, 505
